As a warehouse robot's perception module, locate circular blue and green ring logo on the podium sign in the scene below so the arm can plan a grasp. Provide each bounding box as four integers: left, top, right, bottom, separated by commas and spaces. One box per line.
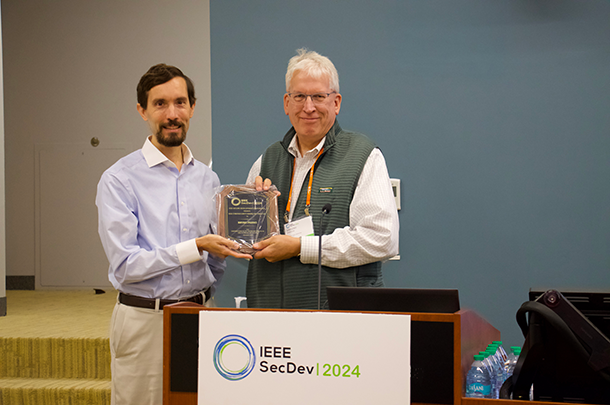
214, 335, 256, 381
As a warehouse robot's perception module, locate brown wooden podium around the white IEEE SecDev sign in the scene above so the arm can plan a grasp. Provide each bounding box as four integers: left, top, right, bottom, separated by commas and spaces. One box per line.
163, 302, 500, 405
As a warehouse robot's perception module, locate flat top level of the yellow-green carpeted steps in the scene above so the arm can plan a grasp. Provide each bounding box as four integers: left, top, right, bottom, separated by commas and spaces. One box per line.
0, 289, 117, 339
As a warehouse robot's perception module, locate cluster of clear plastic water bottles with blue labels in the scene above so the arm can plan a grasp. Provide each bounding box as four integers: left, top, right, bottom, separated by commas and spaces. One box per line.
466, 341, 521, 399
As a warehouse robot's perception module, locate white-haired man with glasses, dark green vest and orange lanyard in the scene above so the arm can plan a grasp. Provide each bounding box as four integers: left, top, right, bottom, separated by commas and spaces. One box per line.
246, 49, 399, 309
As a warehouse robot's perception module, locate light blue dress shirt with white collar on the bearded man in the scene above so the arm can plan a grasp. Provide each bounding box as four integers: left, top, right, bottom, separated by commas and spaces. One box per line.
96, 139, 226, 299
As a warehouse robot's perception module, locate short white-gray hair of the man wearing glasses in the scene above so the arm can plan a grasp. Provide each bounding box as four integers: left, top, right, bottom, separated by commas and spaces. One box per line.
286, 48, 339, 93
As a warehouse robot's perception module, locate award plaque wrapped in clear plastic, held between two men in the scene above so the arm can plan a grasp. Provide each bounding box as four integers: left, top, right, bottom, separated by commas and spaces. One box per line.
216, 185, 279, 254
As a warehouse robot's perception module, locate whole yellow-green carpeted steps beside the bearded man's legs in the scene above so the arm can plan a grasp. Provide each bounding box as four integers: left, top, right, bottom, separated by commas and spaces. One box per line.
0, 290, 116, 405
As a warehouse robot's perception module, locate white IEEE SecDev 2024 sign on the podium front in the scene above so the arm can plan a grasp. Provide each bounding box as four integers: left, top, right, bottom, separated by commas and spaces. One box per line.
198, 310, 411, 405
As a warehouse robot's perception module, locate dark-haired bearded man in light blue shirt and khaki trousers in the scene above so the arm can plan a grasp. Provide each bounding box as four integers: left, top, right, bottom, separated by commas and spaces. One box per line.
96, 64, 250, 405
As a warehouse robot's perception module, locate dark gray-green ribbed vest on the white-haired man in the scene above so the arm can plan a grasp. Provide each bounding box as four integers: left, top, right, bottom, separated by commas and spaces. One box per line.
246, 121, 383, 309
